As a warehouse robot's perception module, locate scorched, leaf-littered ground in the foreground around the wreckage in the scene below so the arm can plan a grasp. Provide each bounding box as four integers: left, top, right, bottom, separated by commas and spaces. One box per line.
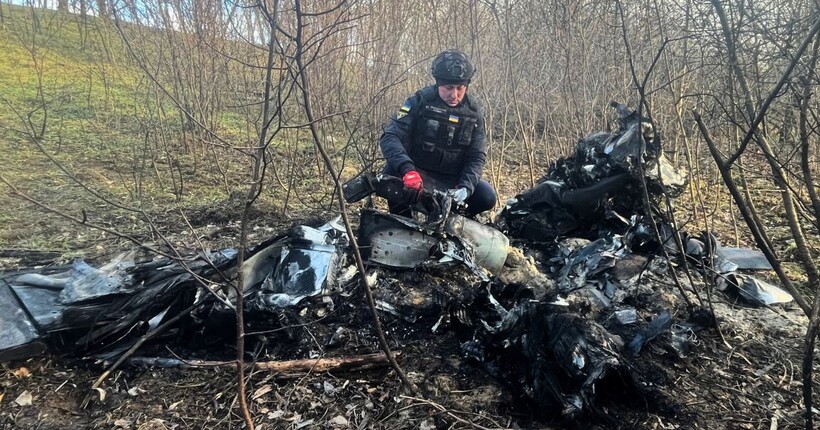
0, 207, 817, 429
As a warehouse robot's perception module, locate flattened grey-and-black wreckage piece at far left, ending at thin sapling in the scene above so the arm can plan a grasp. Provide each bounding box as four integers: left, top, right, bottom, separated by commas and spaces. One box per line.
0, 250, 235, 362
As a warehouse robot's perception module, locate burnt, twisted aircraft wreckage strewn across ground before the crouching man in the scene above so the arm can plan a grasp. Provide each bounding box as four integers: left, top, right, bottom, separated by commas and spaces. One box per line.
0, 105, 791, 418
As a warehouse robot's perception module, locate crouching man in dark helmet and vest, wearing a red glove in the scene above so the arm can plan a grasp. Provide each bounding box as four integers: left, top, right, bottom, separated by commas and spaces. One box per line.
379, 50, 496, 217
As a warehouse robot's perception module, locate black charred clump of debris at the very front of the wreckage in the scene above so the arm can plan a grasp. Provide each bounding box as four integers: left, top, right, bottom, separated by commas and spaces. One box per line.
470, 302, 622, 418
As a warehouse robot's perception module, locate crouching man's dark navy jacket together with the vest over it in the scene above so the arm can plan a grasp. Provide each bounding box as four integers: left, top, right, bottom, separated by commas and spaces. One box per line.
379, 85, 487, 193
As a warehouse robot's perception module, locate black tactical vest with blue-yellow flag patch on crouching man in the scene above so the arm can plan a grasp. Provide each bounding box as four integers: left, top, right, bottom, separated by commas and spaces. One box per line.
408, 87, 479, 176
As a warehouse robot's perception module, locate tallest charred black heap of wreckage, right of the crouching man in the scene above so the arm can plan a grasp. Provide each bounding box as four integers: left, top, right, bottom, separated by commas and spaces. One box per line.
497, 103, 686, 242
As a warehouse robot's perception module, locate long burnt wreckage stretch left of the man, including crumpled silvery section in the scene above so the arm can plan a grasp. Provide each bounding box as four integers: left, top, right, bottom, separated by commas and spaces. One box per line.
0, 222, 349, 359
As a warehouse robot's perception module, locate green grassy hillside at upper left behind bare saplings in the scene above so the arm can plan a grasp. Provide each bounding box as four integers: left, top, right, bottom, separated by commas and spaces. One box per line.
0, 5, 278, 252
